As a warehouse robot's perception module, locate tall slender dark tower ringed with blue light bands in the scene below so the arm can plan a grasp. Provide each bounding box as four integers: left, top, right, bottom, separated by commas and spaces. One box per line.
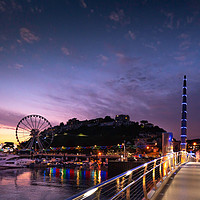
181, 75, 187, 151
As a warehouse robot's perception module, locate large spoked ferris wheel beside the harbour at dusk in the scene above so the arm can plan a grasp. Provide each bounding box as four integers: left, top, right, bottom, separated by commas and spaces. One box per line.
16, 115, 54, 150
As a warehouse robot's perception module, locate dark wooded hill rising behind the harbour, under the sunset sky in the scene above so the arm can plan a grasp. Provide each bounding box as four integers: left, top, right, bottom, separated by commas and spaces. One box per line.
51, 116, 166, 147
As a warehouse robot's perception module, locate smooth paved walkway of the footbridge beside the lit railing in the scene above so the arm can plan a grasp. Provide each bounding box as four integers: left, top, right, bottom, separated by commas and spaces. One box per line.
157, 162, 200, 200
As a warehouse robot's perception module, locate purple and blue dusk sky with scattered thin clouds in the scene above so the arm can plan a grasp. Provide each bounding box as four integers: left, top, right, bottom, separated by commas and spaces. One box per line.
0, 0, 200, 142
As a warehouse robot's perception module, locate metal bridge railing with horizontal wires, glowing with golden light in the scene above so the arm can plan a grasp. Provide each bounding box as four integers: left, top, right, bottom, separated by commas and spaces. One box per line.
67, 152, 196, 200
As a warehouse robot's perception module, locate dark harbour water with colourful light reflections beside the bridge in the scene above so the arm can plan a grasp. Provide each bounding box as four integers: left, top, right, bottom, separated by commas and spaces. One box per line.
0, 168, 108, 200
